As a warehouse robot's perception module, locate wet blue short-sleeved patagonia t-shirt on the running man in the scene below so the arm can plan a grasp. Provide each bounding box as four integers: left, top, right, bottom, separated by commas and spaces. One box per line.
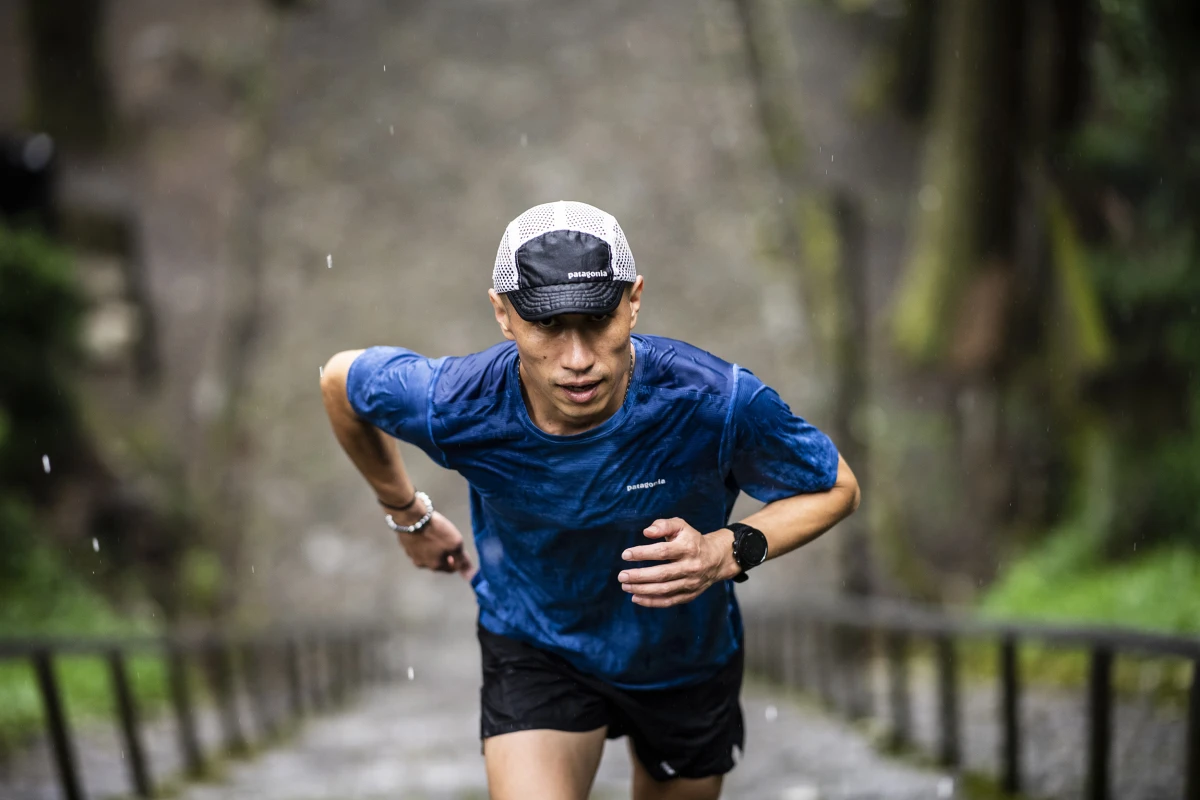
347, 336, 838, 688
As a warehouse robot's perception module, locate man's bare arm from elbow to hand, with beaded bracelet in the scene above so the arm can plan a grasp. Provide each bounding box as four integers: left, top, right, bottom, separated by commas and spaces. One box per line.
320, 350, 475, 581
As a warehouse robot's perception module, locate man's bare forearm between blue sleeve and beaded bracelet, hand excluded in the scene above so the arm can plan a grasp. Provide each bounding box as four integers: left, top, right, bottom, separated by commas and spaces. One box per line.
320, 350, 424, 513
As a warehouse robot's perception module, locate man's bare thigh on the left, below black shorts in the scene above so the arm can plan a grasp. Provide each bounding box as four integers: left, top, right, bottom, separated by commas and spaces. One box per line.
484, 728, 604, 800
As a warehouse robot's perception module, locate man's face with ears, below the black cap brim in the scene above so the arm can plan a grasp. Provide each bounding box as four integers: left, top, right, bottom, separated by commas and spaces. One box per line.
488, 276, 642, 427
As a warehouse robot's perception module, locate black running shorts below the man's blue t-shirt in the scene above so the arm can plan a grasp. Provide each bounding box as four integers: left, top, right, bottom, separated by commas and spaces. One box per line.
479, 627, 745, 781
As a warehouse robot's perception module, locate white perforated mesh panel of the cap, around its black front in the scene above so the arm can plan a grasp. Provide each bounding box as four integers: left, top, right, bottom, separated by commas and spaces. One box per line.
492, 200, 637, 294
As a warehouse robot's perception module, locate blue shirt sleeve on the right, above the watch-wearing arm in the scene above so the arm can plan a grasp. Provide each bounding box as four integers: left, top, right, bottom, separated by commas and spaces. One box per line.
732, 367, 838, 503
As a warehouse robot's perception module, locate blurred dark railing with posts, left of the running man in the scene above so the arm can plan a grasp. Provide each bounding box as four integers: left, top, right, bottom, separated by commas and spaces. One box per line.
0, 625, 392, 800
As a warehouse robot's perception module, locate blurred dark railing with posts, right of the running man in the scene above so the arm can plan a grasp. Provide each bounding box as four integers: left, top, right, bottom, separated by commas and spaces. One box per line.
745, 601, 1200, 800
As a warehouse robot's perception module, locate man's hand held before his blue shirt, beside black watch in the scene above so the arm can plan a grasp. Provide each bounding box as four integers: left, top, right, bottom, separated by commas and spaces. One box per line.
617, 517, 740, 608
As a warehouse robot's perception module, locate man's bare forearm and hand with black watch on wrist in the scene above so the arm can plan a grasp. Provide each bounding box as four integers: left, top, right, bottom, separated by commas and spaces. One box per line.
618, 455, 862, 608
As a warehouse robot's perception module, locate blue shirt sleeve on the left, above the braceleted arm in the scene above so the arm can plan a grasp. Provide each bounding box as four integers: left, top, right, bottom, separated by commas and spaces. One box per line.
346, 347, 442, 452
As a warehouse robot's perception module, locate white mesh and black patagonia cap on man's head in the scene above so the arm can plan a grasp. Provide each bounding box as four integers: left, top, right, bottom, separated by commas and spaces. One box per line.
492, 200, 637, 321
